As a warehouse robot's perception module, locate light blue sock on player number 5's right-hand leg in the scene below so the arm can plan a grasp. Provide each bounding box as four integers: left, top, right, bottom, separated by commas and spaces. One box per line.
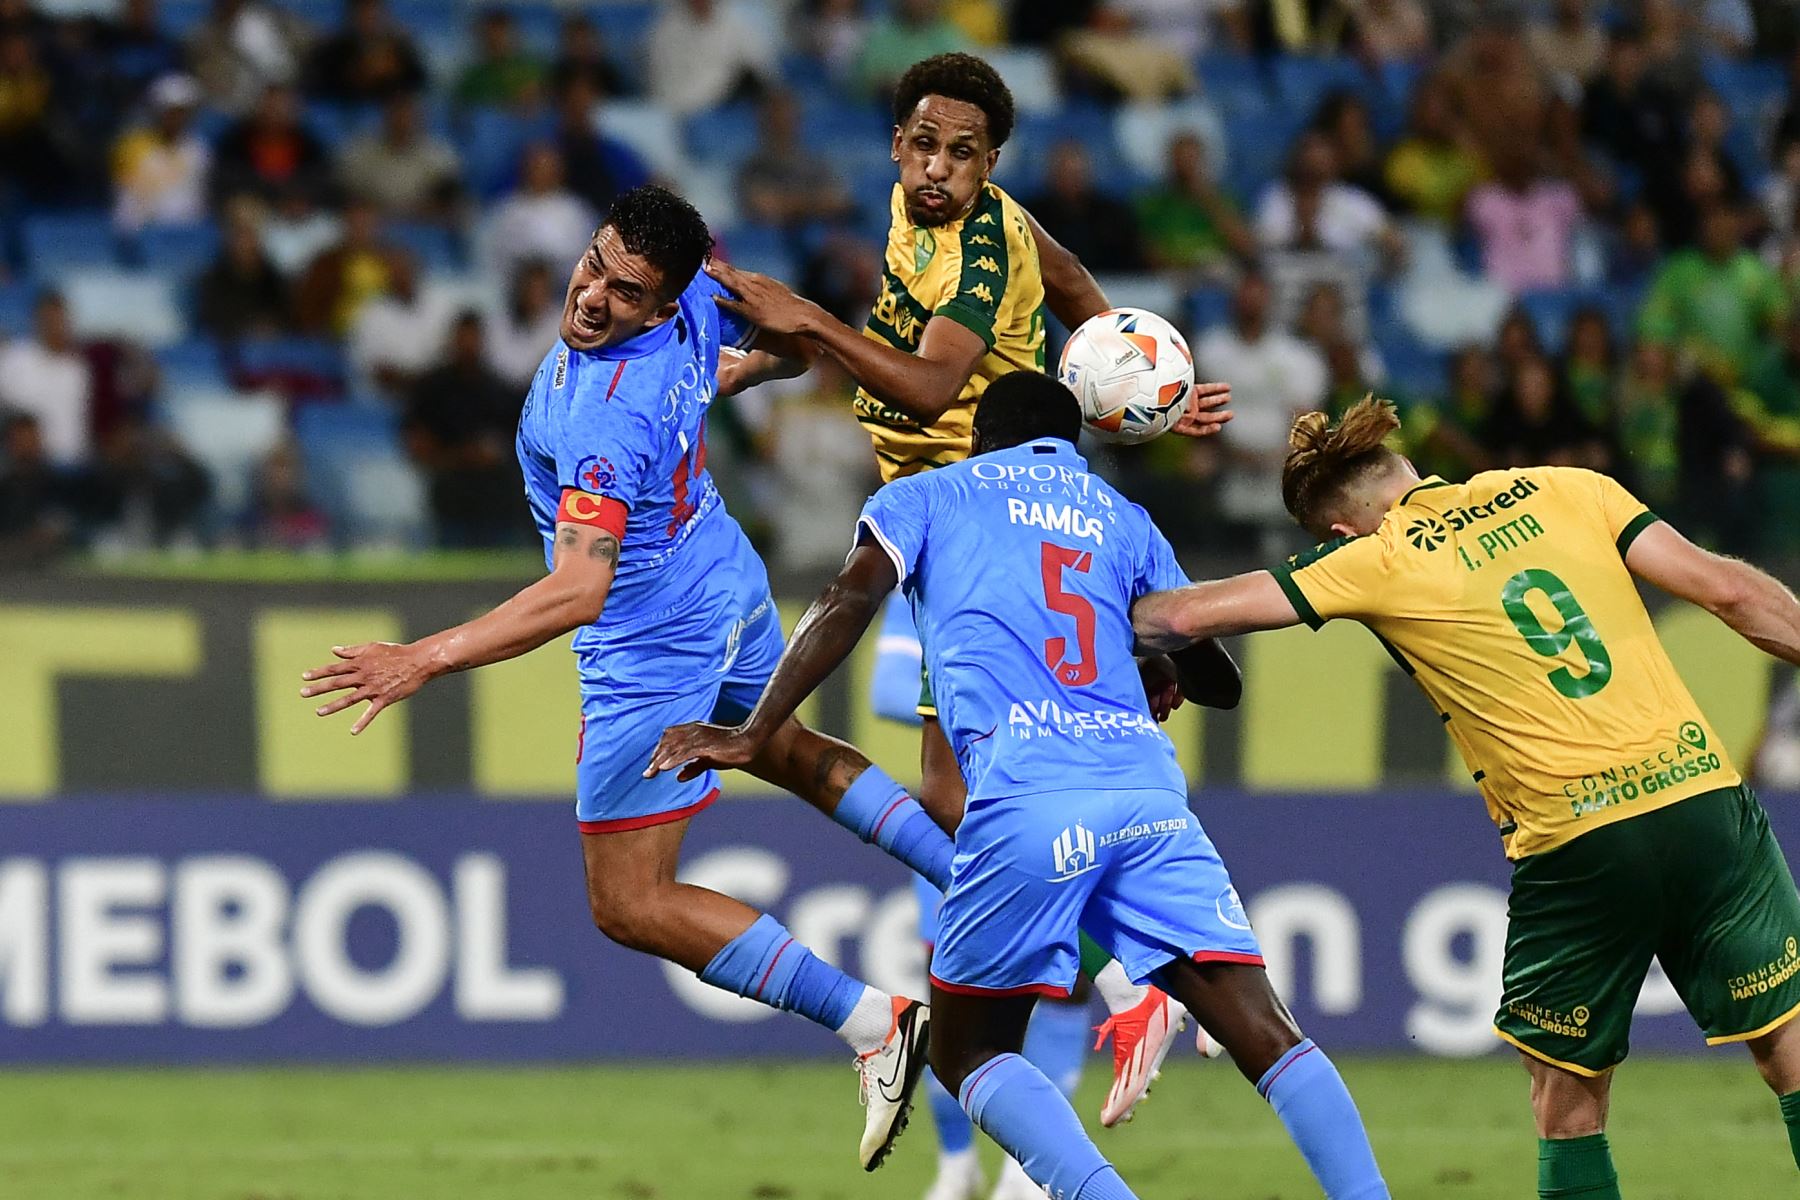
1256, 1038, 1388, 1200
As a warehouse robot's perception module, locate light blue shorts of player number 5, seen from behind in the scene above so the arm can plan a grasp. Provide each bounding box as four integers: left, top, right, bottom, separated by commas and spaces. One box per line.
931, 790, 1262, 997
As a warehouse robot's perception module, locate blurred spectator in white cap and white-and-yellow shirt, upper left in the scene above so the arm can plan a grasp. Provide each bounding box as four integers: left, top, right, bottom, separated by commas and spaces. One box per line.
113, 76, 212, 234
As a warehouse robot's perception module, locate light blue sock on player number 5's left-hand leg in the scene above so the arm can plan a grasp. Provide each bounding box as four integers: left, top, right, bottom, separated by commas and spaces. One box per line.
958, 1054, 1138, 1200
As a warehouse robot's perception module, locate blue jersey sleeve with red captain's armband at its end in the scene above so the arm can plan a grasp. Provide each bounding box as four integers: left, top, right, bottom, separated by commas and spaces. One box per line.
554, 362, 653, 540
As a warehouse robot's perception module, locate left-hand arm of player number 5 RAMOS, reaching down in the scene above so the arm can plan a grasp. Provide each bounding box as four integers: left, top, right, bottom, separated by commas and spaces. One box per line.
644, 543, 900, 779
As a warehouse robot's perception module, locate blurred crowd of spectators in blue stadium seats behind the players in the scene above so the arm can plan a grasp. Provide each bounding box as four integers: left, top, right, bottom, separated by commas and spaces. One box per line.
0, 0, 1800, 572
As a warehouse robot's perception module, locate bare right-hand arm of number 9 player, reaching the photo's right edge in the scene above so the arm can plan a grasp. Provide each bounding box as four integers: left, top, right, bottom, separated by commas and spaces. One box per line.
1625, 522, 1800, 666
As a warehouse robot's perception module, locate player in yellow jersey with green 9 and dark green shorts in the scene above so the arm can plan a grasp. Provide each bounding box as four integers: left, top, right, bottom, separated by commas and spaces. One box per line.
1132, 399, 1800, 1200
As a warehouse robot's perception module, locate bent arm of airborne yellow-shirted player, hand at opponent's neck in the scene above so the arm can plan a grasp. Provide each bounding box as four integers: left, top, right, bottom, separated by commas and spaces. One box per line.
706, 261, 988, 425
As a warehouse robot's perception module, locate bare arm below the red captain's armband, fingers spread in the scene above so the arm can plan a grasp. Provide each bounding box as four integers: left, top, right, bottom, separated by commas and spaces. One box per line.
301, 522, 619, 734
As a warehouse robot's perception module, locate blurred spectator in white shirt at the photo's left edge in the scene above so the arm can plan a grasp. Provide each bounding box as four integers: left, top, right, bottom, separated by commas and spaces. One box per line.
0, 291, 94, 468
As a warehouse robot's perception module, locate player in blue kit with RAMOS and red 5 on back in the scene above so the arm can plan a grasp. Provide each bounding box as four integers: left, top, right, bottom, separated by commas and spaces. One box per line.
652, 371, 1388, 1200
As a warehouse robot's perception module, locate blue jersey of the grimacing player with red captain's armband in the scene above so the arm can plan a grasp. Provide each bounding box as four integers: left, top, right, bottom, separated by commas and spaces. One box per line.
518, 272, 751, 665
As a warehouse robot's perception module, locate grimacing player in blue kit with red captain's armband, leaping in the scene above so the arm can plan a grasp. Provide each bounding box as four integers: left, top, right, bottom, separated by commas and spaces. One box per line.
301, 187, 979, 1169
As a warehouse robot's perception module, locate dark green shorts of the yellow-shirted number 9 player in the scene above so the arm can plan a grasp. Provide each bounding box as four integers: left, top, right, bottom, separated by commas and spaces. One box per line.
1494, 784, 1800, 1076
